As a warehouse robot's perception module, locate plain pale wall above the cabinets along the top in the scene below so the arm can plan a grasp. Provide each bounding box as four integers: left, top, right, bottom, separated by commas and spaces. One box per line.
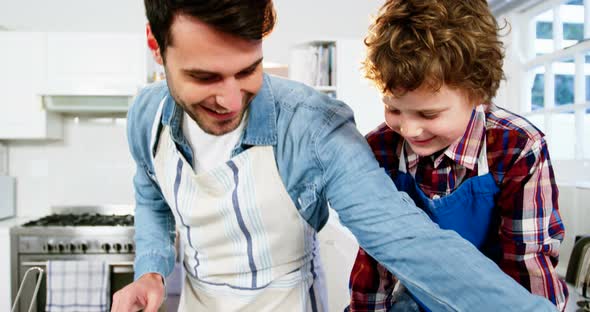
0, 0, 383, 64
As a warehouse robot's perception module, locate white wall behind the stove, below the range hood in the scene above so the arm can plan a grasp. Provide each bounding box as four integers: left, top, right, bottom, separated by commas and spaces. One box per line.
8, 117, 135, 216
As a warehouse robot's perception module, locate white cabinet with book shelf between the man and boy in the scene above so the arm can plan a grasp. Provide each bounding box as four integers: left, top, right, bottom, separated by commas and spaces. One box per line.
289, 38, 384, 134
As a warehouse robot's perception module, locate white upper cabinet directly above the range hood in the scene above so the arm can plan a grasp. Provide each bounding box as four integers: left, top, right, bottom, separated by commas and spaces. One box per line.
43, 33, 147, 96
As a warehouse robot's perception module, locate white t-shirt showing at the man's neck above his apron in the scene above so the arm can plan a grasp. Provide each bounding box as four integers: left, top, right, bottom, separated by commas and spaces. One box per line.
182, 112, 247, 173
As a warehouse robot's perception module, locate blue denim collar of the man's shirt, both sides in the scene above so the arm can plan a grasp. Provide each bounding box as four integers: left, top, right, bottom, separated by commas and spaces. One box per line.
161, 74, 277, 148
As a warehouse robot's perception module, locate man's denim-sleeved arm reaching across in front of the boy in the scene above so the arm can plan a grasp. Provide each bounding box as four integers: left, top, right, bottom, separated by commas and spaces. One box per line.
313, 109, 555, 311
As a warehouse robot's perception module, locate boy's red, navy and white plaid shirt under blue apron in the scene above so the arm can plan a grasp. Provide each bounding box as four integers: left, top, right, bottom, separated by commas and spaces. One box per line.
350, 105, 568, 311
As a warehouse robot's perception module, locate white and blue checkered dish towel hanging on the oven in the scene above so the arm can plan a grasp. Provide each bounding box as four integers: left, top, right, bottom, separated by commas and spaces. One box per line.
45, 261, 110, 312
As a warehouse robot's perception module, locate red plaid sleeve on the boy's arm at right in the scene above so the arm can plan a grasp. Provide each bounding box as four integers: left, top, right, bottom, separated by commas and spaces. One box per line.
498, 138, 568, 310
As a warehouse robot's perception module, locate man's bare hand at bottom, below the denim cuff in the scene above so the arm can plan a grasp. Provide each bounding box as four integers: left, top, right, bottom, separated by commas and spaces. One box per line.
112, 273, 164, 312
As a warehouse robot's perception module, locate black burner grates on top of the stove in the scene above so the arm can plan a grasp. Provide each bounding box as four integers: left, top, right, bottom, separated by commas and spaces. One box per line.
23, 213, 133, 227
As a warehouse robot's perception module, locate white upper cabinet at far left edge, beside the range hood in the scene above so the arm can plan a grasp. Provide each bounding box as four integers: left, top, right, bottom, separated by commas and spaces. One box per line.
0, 32, 61, 140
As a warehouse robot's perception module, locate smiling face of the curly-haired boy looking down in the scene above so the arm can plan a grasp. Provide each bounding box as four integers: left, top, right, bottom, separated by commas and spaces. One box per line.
383, 85, 474, 156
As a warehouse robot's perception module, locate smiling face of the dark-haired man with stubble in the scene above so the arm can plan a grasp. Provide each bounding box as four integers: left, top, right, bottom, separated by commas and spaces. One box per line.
164, 15, 263, 135
